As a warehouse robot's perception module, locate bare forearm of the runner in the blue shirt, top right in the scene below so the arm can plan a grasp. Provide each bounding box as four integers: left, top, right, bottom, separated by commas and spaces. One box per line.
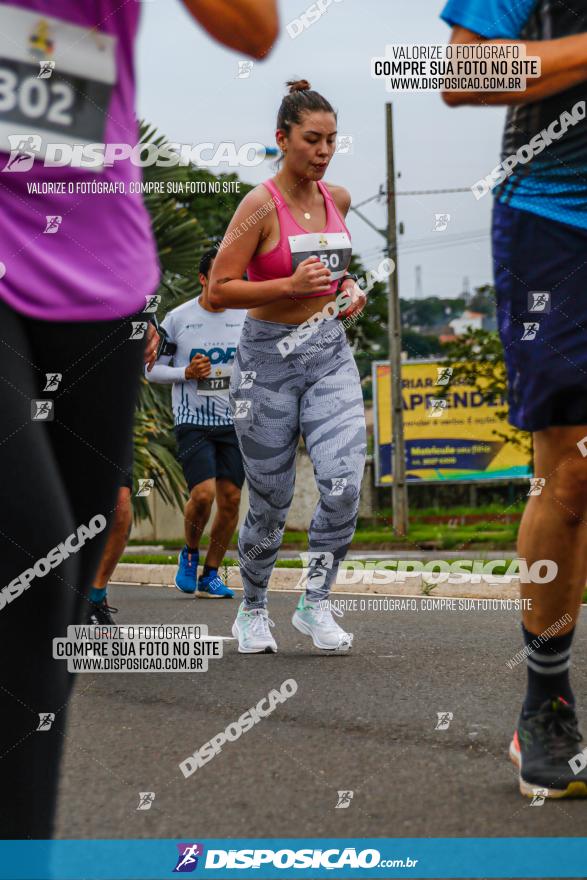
442, 27, 587, 109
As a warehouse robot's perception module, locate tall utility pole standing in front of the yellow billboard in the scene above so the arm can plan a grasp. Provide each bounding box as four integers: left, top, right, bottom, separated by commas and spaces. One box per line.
385, 103, 408, 535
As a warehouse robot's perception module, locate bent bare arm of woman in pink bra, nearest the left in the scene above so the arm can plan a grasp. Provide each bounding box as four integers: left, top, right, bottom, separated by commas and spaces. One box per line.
208, 186, 331, 309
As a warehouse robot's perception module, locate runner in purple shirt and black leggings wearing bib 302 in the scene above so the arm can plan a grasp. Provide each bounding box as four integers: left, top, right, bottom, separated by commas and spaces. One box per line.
0, 0, 277, 839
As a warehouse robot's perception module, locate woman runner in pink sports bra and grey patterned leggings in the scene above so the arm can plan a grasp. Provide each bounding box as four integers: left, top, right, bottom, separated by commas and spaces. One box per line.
210, 80, 366, 653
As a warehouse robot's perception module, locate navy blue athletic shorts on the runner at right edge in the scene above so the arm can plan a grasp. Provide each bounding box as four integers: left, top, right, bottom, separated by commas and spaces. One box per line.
493, 201, 587, 431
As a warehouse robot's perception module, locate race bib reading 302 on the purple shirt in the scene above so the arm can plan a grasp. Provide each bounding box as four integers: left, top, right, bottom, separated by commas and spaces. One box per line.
0, 6, 116, 158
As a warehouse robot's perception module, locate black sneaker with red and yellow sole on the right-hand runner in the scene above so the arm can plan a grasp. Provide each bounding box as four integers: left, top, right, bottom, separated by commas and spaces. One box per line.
510, 697, 587, 798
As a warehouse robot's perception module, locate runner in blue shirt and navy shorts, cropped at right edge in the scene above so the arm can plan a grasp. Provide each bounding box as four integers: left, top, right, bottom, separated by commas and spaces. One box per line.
442, 0, 587, 797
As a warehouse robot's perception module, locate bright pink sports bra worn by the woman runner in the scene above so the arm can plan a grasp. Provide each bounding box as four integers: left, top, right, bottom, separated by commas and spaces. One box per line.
247, 180, 352, 299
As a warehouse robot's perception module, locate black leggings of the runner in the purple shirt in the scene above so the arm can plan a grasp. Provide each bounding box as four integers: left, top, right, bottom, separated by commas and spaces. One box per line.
0, 302, 144, 839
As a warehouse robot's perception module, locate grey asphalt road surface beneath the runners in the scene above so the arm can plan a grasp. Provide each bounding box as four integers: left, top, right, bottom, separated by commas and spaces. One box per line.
58, 586, 587, 840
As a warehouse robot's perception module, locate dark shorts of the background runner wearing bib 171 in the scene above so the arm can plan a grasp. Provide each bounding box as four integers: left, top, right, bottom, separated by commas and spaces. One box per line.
175, 425, 245, 492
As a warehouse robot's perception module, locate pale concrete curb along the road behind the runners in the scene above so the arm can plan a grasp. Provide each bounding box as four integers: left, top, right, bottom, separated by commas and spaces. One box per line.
111, 562, 520, 599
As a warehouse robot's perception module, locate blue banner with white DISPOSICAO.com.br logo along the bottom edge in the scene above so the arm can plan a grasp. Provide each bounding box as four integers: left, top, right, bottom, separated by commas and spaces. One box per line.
0, 837, 587, 880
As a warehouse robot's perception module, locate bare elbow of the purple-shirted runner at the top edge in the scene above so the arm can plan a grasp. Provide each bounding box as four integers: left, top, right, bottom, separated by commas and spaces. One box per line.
183, 0, 279, 59
